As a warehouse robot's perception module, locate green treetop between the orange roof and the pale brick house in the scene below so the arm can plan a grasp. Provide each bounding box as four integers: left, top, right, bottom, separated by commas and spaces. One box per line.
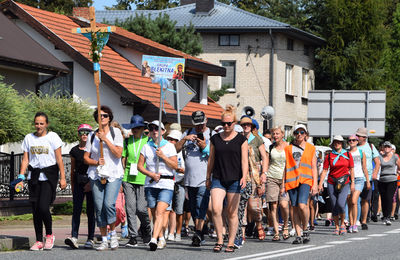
115, 14, 202, 56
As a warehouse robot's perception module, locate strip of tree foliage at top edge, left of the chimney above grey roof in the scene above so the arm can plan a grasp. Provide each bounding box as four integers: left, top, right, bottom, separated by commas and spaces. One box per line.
107, 0, 179, 10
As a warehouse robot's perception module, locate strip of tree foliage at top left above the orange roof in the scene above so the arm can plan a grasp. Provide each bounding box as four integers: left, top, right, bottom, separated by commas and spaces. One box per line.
18, 0, 93, 15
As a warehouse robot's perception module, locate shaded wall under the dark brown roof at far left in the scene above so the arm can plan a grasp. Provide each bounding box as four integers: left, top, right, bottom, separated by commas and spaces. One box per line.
0, 66, 39, 95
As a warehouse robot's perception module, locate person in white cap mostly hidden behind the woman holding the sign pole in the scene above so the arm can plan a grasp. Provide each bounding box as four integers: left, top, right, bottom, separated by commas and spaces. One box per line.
166, 130, 185, 242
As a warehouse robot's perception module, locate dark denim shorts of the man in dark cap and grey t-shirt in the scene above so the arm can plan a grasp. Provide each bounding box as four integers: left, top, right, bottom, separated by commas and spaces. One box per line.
186, 186, 210, 220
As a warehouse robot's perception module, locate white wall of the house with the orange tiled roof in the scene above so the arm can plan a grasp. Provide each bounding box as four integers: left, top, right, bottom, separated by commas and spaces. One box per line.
16, 20, 133, 123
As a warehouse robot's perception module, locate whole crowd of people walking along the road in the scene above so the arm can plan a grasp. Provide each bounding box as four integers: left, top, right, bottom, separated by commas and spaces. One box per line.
18, 105, 400, 253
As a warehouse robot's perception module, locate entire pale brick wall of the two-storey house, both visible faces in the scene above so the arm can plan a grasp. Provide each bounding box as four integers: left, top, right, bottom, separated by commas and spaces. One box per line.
200, 33, 314, 132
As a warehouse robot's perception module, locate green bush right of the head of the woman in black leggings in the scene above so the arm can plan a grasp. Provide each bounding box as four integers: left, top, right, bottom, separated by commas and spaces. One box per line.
25, 93, 96, 143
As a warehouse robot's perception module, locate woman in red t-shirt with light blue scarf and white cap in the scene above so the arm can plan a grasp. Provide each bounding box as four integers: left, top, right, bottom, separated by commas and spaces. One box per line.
319, 135, 355, 235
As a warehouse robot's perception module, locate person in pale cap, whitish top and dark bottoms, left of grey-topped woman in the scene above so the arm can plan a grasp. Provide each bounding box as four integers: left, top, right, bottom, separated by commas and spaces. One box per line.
356, 127, 381, 230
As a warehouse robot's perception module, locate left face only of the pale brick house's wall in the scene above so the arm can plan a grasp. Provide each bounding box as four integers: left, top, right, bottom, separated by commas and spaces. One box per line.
200, 33, 271, 123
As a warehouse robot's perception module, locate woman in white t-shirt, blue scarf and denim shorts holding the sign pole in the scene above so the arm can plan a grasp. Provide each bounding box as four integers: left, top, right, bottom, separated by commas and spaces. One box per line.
138, 120, 178, 251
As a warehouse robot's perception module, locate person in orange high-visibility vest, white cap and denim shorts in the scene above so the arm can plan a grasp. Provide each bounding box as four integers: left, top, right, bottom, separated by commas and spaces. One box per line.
281, 124, 318, 244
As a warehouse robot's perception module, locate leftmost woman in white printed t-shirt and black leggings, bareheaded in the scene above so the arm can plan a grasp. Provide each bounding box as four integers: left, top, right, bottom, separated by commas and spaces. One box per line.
18, 112, 67, 251
